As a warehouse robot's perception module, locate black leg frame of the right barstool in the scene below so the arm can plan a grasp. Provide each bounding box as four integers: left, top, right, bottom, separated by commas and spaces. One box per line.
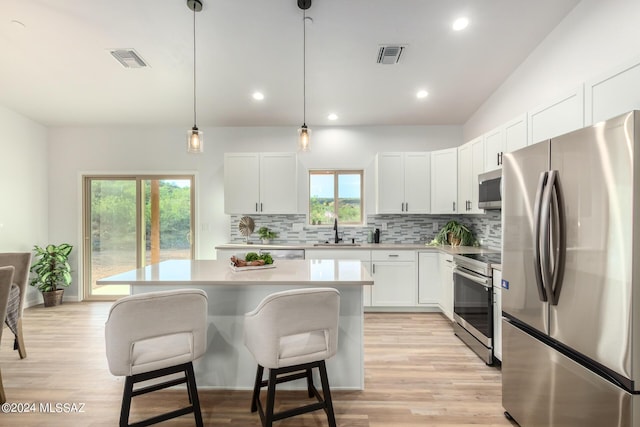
251, 360, 336, 427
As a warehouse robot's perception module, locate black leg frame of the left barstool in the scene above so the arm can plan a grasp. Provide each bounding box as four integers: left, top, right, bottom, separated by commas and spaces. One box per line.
120, 362, 203, 427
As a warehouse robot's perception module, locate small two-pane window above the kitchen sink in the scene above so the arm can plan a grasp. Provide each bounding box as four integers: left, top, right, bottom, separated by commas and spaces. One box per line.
309, 170, 363, 225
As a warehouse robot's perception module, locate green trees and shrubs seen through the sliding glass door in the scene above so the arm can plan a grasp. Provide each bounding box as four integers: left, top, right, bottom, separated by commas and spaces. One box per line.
91, 180, 191, 250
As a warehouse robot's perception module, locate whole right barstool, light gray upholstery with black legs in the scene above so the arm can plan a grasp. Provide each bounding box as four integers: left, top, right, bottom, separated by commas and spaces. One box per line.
244, 288, 340, 427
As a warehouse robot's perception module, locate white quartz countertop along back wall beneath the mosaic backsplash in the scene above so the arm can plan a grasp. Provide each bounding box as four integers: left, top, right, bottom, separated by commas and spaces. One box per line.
215, 243, 500, 255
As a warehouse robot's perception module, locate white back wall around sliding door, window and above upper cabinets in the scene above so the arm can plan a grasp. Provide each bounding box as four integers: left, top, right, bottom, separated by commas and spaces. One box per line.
48, 126, 462, 297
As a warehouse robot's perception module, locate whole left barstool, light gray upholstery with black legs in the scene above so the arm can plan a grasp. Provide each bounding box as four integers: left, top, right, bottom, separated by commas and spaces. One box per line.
105, 289, 207, 426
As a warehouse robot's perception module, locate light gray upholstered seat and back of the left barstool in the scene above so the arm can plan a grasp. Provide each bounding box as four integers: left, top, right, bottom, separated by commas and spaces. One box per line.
105, 289, 207, 376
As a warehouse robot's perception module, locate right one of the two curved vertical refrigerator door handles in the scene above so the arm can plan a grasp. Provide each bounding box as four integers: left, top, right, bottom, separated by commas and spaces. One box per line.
549, 171, 567, 305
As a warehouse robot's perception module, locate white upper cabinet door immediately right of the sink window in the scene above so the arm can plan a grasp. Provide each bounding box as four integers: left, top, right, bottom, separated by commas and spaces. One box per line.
376, 153, 404, 214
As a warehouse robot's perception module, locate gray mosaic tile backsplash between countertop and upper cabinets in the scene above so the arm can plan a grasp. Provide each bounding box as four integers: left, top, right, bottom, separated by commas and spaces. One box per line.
230, 211, 502, 249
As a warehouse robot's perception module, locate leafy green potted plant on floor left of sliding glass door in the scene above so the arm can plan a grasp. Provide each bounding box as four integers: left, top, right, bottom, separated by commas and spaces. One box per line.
29, 243, 73, 307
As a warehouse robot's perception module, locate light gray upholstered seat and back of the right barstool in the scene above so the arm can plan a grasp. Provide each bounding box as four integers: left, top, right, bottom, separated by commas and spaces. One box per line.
244, 288, 340, 369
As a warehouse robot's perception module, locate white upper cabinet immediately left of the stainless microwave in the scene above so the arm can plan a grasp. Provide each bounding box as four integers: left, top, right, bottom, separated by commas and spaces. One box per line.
458, 138, 484, 214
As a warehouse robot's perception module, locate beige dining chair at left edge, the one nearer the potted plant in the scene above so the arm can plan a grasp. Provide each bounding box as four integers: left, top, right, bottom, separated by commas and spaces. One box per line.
0, 252, 31, 359
